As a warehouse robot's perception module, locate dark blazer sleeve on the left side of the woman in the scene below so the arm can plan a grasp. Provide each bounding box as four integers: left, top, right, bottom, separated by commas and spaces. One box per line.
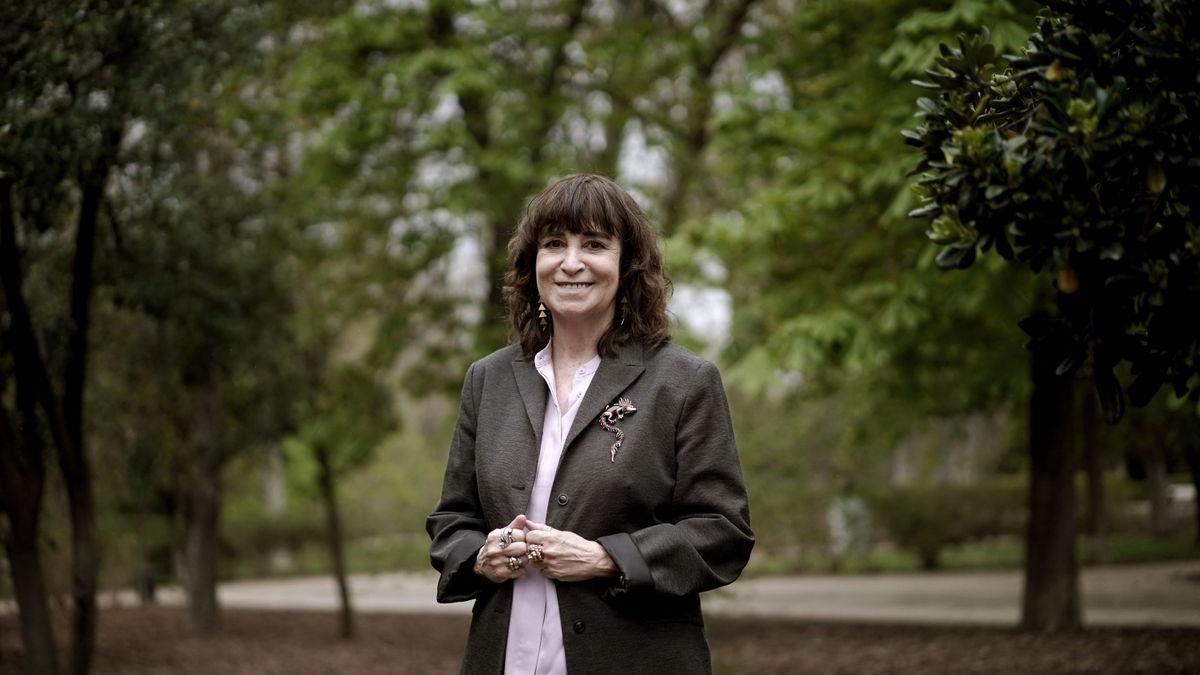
425, 365, 488, 603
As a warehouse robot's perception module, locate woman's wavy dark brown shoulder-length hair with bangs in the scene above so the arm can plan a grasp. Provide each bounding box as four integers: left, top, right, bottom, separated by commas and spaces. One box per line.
504, 174, 671, 359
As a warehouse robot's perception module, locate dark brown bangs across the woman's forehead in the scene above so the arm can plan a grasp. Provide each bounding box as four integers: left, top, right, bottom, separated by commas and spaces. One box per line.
528, 175, 629, 240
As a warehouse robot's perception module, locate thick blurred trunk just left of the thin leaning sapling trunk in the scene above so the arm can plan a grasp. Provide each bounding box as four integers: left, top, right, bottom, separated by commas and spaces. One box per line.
187, 376, 224, 632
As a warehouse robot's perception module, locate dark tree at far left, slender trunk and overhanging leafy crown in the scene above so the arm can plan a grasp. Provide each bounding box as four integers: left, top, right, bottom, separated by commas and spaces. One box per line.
0, 1, 274, 643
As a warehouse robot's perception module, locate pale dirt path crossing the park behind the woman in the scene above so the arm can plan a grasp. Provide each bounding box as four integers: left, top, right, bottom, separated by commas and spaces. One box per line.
93, 560, 1200, 627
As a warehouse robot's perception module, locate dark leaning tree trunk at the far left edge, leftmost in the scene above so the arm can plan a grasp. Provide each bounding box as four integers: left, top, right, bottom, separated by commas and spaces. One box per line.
0, 398, 59, 675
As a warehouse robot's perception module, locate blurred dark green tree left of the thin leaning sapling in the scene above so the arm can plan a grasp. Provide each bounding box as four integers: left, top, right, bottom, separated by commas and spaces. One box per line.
105, 117, 299, 631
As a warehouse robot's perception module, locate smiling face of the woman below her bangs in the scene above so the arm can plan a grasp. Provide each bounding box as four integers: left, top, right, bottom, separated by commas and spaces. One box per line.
536, 232, 620, 330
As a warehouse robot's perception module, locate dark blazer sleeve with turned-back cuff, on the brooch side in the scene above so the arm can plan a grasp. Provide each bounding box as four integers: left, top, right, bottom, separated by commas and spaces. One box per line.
599, 362, 755, 596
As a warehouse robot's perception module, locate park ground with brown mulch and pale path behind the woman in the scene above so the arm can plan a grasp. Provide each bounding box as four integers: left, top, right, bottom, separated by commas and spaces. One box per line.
0, 560, 1200, 675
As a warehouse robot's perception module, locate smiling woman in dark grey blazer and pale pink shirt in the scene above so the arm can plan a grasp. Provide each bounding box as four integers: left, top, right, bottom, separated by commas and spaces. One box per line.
426, 175, 754, 675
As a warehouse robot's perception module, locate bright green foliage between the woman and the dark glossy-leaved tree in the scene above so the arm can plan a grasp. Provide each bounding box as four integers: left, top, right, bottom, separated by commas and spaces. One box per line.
700, 2, 1030, 429
